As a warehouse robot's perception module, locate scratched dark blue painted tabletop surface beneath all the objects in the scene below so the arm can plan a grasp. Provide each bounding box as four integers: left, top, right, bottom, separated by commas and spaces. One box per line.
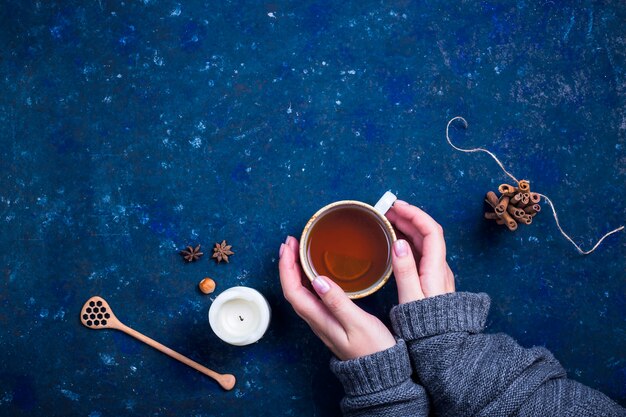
0, 0, 626, 417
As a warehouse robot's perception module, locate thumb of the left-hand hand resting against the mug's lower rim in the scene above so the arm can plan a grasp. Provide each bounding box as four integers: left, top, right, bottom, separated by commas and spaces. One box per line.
312, 276, 365, 331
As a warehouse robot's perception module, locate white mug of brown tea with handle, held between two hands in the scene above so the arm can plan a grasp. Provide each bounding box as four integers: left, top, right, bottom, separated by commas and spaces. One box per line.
300, 191, 396, 299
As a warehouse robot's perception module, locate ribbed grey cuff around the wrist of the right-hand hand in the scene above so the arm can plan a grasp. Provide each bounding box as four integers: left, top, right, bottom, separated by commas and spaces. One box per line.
390, 292, 490, 342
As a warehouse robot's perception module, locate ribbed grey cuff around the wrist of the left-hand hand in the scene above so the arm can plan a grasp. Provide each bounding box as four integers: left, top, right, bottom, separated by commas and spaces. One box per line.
330, 340, 411, 396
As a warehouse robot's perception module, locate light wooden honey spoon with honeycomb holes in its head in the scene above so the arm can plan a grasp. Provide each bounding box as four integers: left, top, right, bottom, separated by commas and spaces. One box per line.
80, 296, 236, 390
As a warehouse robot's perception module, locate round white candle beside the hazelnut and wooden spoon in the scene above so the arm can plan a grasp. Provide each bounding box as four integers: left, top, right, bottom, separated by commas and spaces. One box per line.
209, 287, 270, 346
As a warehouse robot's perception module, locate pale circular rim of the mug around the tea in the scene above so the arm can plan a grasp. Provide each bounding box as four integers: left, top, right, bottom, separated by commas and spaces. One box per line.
299, 200, 397, 300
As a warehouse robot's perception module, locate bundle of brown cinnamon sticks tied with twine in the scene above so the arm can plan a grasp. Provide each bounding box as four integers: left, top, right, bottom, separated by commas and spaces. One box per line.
485, 180, 541, 231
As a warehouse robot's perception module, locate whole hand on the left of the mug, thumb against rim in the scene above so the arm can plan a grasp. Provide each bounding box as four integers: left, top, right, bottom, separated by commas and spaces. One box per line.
278, 236, 396, 361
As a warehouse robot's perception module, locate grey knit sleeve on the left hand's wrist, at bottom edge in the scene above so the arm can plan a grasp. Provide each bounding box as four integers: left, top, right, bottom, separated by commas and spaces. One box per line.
330, 340, 429, 417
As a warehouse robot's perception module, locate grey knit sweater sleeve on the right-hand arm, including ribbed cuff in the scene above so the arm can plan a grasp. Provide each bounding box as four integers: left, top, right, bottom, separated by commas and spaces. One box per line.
391, 292, 626, 416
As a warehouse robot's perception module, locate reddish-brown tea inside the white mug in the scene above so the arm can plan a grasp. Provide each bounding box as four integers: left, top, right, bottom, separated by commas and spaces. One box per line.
307, 207, 390, 292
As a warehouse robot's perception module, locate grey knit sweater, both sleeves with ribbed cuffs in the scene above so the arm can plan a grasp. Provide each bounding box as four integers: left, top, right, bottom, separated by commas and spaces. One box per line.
331, 292, 626, 417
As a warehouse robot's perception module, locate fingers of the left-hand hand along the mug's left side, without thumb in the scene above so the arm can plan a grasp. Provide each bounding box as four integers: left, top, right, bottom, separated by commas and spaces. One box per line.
278, 242, 341, 333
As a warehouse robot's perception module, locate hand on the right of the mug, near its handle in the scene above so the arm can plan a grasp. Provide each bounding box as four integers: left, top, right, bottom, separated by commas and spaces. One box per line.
386, 200, 454, 304
